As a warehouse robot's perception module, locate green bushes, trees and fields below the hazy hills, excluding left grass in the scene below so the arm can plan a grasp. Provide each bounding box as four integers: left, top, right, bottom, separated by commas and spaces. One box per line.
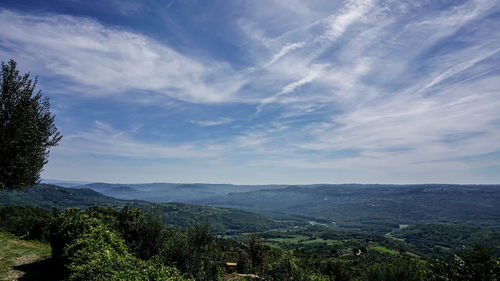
0, 203, 500, 281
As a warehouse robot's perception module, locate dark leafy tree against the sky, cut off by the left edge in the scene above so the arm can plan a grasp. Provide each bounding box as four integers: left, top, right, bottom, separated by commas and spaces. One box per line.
0, 60, 62, 190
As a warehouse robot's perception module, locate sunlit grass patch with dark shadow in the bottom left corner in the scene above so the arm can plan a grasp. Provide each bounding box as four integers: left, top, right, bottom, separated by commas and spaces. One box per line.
0, 233, 51, 280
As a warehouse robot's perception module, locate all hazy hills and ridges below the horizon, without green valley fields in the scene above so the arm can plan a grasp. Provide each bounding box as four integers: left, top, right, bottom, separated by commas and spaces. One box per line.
0, 183, 500, 253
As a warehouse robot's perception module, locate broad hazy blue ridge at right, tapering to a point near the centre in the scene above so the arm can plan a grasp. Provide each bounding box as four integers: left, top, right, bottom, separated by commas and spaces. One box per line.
192, 184, 500, 232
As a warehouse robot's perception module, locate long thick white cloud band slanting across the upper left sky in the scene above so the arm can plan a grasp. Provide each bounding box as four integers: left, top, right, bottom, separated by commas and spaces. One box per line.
0, 10, 241, 103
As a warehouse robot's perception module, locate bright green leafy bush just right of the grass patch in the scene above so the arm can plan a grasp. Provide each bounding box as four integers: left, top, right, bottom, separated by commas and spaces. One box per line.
50, 207, 191, 281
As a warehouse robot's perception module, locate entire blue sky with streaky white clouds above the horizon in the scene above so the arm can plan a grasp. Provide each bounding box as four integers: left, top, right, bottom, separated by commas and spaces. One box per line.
0, 0, 500, 184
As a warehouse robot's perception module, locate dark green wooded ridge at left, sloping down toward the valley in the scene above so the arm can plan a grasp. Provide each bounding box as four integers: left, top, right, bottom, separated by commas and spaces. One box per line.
0, 184, 285, 234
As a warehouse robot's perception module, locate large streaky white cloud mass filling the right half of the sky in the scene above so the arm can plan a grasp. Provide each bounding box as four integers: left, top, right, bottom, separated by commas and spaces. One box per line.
226, 1, 500, 182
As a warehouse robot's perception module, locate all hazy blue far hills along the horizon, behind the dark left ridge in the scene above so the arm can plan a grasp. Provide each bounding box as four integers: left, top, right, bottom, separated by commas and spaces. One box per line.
38, 180, 500, 234
